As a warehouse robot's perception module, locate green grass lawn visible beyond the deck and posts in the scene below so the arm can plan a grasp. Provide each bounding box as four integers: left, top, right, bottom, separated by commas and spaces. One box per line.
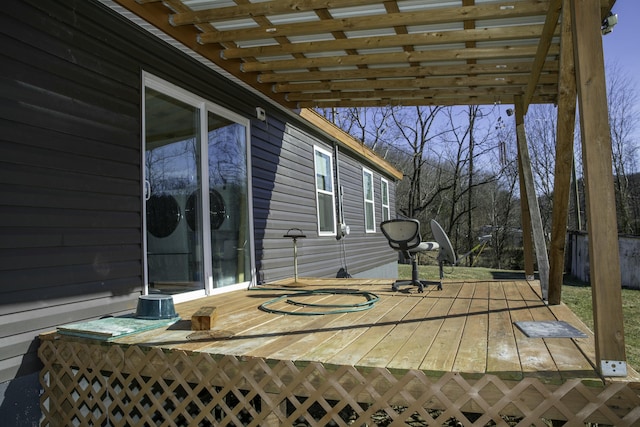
398, 265, 640, 370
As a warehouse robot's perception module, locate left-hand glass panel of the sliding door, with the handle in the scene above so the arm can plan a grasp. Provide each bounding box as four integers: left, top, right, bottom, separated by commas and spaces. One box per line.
145, 88, 204, 294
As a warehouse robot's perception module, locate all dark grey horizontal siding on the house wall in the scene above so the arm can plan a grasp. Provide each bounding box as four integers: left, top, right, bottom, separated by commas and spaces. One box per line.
0, 0, 395, 413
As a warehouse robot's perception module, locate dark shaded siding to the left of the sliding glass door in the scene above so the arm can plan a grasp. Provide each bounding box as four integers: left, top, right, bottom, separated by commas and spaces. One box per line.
0, 1, 148, 382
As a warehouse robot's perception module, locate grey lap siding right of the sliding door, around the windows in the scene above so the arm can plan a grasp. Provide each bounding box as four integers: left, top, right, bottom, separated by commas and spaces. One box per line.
253, 119, 397, 281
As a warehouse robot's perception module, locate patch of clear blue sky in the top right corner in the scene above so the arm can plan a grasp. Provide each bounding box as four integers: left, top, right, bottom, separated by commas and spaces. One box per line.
602, 0, 640, 86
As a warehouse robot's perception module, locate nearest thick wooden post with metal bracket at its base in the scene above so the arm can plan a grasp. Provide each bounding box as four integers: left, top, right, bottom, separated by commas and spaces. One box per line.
571, 0, 626, 376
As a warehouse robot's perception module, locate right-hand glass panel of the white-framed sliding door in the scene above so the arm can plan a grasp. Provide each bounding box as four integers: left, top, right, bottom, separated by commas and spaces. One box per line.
207, 112, 251, 287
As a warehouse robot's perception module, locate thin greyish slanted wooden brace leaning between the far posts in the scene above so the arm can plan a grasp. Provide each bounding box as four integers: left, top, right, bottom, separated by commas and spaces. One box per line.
514, 96, 549, 301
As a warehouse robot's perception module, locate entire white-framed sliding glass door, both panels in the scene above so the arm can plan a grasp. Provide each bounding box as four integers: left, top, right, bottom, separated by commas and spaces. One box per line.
144, 77, 252, 296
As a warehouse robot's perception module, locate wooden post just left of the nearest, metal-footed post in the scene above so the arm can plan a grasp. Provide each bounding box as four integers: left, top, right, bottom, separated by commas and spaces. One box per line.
549, 0, 577, 305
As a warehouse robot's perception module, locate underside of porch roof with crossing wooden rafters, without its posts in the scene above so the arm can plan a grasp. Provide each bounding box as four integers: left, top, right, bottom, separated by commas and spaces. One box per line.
114, 0, 584, 108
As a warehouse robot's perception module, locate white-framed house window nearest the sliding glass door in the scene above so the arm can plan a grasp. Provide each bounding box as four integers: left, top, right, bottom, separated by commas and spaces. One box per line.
313, 147, 336, 236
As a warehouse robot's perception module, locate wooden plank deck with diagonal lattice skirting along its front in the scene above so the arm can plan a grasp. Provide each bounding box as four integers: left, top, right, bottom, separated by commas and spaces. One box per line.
41, 279, 640, 425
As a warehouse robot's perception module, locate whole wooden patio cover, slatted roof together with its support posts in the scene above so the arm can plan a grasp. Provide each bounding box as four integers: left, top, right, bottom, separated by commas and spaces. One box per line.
114, 0, 626, 375
